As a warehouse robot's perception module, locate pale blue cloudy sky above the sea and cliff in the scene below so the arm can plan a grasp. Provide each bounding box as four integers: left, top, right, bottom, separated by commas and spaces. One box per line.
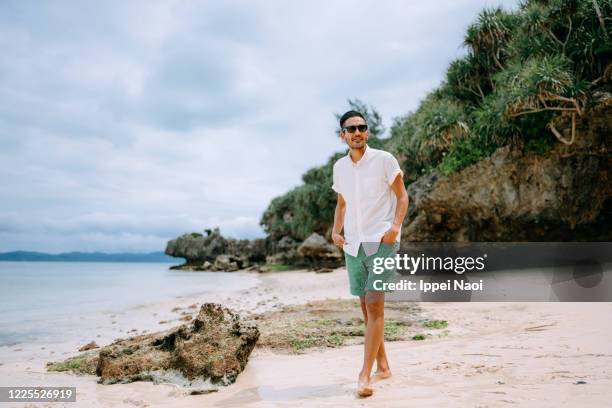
0, 0, 517, 253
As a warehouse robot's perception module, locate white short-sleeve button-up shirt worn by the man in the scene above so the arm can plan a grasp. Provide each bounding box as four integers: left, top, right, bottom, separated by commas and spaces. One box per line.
332, 145, 404, 256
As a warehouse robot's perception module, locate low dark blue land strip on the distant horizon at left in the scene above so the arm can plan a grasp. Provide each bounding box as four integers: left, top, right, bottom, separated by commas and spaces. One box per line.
0, 251, 176, 262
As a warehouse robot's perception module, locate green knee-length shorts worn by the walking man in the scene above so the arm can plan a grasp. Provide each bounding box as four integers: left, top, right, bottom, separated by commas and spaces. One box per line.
344, 243, 397, 296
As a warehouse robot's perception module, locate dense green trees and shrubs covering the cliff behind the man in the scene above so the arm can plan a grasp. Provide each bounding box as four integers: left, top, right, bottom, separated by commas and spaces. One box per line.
261, 0, 612, 240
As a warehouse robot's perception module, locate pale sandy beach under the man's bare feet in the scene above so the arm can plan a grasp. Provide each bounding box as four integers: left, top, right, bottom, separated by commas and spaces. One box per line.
0, 269, 612, 407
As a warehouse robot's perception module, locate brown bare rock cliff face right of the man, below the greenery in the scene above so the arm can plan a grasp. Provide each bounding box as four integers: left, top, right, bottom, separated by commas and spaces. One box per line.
402, 91, 612, 242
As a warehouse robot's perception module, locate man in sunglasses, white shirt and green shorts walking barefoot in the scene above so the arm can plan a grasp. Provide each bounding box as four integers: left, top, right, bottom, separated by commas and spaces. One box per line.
332, 111, 408, 397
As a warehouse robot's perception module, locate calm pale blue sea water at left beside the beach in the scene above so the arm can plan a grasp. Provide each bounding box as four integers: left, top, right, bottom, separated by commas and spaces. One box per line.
0, 262, 258, 346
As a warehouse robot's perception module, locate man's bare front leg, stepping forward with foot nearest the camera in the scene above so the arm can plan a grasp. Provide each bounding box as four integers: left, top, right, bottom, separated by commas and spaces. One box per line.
358, 291, 385, 396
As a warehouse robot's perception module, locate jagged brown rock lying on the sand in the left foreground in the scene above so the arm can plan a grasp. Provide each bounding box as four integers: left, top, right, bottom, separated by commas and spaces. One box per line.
48, 303, 259, 387
